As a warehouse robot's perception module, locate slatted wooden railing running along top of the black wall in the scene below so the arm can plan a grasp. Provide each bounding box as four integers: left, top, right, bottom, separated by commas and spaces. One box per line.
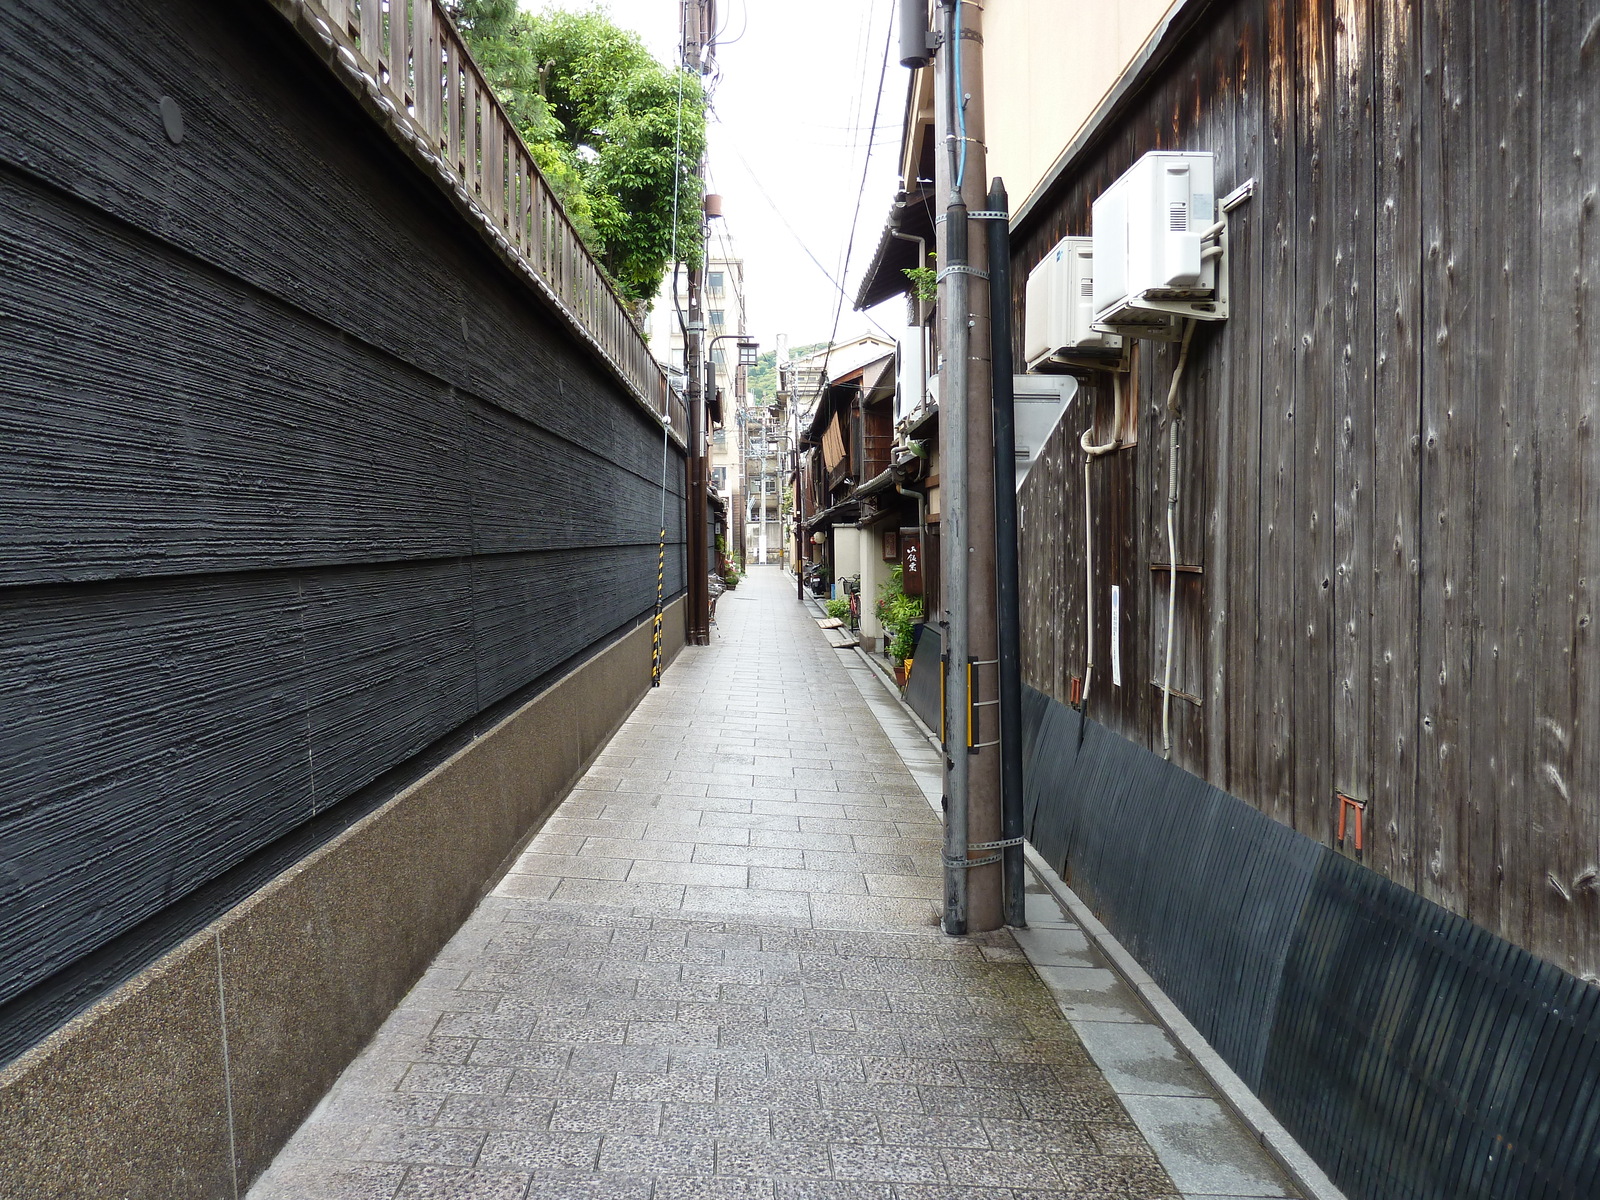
304, 0, 688, 438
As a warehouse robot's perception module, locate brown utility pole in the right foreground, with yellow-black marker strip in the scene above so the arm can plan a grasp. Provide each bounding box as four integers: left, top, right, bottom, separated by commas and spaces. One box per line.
934, 0, 1003, 934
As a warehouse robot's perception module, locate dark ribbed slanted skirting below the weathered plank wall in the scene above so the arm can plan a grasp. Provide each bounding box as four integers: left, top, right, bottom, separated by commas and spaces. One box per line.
1024, 688, 1600, 1200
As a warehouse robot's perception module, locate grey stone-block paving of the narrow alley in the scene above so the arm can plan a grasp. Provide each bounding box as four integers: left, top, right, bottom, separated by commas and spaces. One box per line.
250, 568, 1174, 1200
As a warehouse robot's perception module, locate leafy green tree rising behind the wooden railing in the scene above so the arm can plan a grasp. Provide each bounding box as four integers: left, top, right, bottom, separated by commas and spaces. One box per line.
450, 0, 706, 304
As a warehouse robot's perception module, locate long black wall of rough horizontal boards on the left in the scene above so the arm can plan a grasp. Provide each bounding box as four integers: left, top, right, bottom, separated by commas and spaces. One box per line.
0, 0, 683, 1053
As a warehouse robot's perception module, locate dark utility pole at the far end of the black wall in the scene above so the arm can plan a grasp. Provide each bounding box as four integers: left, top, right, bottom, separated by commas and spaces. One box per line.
680, 0, 717, 646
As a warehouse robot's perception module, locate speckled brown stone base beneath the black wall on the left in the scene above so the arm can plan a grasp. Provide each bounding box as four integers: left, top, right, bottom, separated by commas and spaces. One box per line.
0, 600, 683, 1200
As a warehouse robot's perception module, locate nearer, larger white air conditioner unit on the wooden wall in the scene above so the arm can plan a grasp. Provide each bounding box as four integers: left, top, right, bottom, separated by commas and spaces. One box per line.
1093, 150, 1227, 341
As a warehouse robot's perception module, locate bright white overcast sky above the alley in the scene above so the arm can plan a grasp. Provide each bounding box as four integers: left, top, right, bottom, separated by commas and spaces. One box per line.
522, 0, 909, 350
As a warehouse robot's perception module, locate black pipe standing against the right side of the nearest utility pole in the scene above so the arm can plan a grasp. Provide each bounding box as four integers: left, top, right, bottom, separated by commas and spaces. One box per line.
986, 178, 1027, 928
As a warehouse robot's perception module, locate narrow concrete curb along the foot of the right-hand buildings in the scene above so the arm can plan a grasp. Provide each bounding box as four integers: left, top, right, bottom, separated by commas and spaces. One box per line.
856, 646, 1346, 1200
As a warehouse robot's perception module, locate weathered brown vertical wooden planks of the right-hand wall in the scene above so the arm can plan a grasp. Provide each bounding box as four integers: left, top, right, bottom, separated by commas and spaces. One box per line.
1013, 0, 1600, 976
